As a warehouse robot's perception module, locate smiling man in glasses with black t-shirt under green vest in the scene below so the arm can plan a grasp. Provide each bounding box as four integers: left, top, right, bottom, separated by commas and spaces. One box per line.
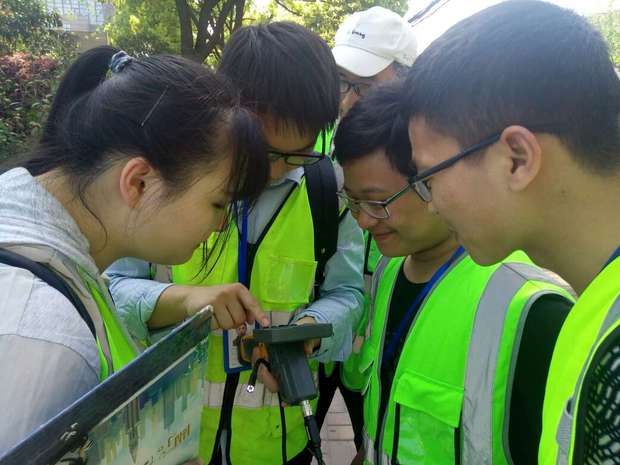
335, 83, 572, 465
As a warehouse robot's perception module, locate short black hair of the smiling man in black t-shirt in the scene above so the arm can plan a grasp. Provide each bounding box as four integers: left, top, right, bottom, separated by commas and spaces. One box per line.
334, 80, 415, 177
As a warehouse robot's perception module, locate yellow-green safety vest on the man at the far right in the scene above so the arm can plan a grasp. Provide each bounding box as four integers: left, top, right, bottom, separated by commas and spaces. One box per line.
538, 257, 620, 465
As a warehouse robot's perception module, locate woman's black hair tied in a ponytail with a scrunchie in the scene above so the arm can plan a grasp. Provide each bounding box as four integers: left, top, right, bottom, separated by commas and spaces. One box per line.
23, 46, 269, 204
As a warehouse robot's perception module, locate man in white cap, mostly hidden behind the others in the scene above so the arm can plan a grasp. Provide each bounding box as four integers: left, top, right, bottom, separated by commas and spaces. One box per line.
317, 6, 417, 449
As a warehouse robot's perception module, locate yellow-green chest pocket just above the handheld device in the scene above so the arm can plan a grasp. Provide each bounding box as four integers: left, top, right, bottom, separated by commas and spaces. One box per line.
251, 253, 317, 310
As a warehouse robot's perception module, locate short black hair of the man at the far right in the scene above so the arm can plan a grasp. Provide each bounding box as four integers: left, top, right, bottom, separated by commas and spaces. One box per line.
405, 0, 620, 174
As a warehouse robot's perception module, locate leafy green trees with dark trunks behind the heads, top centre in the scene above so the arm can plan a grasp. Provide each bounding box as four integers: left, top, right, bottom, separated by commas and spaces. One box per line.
106, 0, 407, 64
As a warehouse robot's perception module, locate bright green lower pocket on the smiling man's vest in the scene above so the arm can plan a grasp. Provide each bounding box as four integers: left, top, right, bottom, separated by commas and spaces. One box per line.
392, 371, 464, 465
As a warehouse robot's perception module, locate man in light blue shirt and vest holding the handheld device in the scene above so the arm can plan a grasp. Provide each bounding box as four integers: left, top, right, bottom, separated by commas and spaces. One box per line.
108, 22, 363, 465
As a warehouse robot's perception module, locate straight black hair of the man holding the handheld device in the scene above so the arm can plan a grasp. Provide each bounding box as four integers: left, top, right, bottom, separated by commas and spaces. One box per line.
218, 21, 340, 134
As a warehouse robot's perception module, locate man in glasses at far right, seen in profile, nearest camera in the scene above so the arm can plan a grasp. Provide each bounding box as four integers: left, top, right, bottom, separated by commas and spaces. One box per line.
403, 0, 620, 465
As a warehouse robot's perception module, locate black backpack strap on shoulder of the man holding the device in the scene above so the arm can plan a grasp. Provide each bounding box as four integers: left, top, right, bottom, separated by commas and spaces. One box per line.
304, 157, 340, 297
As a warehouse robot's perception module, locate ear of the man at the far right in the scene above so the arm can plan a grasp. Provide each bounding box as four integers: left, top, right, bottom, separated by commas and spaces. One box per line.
500, 126, 542, 191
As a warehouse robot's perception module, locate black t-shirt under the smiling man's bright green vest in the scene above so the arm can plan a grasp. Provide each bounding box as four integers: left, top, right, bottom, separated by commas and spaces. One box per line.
378, 260, 572, 465
